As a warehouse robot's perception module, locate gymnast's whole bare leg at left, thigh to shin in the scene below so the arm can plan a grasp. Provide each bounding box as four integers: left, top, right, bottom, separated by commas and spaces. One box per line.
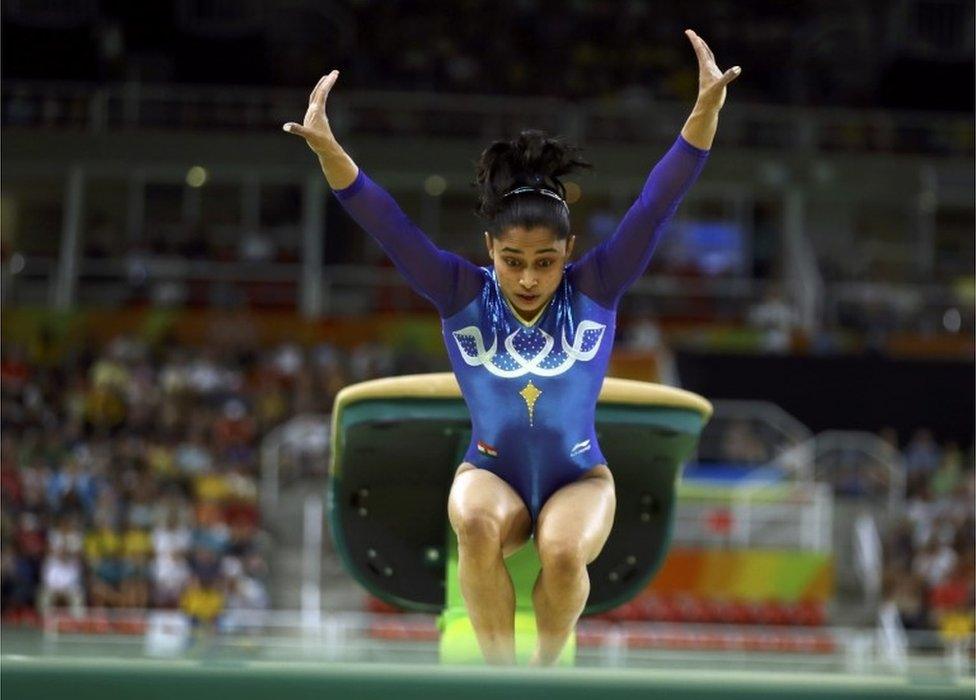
448, 463, 531, 664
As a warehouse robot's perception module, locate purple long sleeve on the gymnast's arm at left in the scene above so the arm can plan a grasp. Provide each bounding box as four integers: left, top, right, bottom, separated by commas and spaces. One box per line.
334, 168, 484, 318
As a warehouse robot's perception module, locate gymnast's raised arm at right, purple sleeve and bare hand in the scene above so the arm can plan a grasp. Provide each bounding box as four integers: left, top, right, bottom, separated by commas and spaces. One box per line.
572, 29, 742, 308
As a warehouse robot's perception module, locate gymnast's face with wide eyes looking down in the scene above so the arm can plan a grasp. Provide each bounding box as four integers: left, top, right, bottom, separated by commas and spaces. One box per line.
485, 226, 576, 321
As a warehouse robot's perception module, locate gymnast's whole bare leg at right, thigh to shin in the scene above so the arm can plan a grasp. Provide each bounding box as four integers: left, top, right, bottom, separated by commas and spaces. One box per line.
532, 465, 616, 665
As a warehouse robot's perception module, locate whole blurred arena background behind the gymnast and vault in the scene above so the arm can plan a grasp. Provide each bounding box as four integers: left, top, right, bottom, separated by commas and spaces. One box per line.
0, 0, 976, 676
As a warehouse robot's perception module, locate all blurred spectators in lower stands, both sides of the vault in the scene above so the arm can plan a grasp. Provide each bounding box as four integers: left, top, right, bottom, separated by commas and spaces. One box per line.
0, 323, 976, 629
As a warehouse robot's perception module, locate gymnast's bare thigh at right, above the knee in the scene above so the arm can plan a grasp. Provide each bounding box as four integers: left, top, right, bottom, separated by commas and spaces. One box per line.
535, 465, 617, 564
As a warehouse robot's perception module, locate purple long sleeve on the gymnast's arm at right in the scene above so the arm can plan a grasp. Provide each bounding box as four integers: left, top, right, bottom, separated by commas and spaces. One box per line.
570, 135, 708, 309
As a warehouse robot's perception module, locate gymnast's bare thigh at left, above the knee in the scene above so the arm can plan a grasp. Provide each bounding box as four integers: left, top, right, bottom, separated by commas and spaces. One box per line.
447, 462, 532, 556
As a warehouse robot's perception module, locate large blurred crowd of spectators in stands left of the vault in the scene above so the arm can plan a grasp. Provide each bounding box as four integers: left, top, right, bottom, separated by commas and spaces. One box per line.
0, 336, 434, 623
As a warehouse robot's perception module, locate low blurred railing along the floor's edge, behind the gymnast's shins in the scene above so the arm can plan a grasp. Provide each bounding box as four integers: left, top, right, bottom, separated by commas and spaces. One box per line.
34, 610, 976, 680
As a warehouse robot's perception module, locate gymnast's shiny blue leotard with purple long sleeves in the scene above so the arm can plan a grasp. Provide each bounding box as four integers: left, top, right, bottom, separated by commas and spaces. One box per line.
335, 136, 708, 525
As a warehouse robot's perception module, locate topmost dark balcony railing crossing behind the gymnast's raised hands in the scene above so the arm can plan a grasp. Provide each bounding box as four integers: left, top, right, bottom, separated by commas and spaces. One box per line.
0, 80, 974, 157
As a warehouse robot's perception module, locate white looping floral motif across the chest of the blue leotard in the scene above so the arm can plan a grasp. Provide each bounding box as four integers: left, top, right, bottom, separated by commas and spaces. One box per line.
452, 321, 607, 379
